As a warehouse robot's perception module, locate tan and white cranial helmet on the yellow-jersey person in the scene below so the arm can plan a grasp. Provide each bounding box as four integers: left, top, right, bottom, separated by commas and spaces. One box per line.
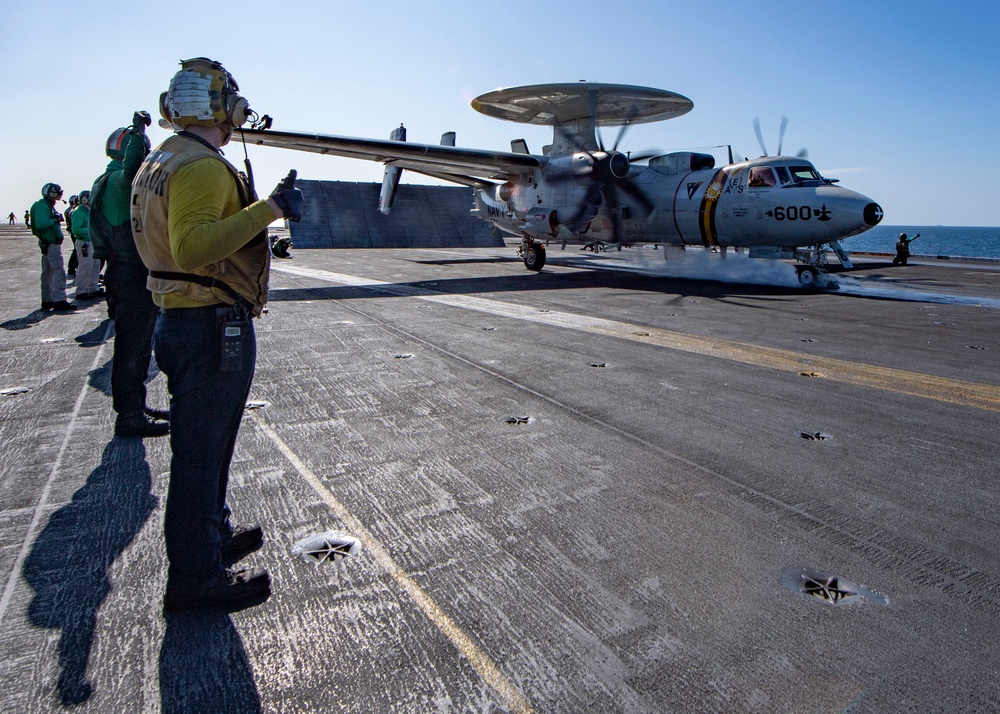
160, 57, 250, 127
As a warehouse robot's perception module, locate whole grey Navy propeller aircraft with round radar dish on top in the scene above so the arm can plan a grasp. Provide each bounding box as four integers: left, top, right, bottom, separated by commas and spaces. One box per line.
244, 82, 882, 286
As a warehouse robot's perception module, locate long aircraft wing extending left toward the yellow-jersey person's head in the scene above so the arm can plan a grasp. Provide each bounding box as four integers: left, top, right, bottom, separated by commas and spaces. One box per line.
236, 129, 544, 186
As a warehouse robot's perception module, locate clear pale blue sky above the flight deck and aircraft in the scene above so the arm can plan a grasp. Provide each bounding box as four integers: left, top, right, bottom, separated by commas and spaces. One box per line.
0, 0, 1000, 226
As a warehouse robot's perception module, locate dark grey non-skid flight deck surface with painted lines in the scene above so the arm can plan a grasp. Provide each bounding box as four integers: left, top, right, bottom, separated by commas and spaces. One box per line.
0, 228, 1000, 712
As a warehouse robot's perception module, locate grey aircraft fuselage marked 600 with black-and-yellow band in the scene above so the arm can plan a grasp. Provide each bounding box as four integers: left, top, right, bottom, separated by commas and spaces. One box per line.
475, 153, 882, 247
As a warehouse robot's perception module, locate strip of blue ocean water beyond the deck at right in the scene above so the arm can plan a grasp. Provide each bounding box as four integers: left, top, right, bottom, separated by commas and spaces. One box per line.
843, 226, 1000, 260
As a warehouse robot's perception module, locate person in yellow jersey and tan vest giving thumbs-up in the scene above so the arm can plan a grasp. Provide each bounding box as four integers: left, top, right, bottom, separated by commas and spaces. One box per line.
131, 57, 303, 610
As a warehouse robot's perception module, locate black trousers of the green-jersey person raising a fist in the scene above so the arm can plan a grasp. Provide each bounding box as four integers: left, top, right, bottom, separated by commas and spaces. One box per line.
104, 260, 160, 414
